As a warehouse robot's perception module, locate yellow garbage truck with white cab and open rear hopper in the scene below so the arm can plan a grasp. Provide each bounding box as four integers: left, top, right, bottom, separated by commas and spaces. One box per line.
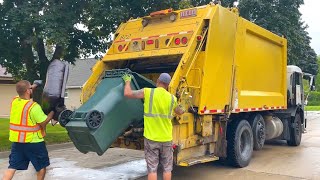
61, 4, 306, 167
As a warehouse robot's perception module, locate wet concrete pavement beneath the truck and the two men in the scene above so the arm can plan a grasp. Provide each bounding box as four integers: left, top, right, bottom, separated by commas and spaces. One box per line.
0, 112, 320, 180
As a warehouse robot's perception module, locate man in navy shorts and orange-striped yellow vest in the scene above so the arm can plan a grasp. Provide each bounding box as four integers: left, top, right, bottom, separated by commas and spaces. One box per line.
3, 80, 54, 180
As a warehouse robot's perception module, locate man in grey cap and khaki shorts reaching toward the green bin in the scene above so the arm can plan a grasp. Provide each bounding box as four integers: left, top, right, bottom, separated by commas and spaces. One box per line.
122, 73, 184, 180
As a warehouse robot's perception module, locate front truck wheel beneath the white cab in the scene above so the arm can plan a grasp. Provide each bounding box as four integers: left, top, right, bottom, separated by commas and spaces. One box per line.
287, 114, 302, 146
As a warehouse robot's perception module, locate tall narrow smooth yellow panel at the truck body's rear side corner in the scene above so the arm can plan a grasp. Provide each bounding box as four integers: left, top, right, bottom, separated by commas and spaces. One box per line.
199, 6, 237, 113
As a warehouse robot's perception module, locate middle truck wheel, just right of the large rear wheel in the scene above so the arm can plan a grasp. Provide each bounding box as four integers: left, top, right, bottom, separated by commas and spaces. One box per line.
249, 114, 266, 151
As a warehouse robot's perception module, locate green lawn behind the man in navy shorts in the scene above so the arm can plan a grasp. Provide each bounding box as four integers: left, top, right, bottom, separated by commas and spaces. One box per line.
0, 118, 70, 151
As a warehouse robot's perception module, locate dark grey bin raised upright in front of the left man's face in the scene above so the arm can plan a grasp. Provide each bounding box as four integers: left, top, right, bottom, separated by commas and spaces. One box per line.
42, 59, 69, 120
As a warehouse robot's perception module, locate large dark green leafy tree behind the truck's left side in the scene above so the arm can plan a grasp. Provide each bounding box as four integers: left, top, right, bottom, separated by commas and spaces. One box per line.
0, 0, 192, 81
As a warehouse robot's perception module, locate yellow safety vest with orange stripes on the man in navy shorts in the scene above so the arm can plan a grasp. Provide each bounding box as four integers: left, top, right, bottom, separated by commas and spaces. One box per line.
9, 97, 45, 143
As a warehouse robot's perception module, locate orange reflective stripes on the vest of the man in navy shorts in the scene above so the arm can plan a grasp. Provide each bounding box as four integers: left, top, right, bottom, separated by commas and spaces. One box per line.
10, 101, 37, 143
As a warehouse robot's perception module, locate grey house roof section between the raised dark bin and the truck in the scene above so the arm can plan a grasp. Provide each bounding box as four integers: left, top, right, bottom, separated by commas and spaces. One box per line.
67, 58, 98, 88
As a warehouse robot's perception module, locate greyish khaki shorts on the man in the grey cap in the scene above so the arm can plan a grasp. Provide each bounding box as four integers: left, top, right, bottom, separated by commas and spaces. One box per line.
144, 138, 173, 173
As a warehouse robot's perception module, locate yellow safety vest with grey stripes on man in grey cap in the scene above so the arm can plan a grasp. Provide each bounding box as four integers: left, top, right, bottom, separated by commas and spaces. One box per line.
144, 88, 177, 142
